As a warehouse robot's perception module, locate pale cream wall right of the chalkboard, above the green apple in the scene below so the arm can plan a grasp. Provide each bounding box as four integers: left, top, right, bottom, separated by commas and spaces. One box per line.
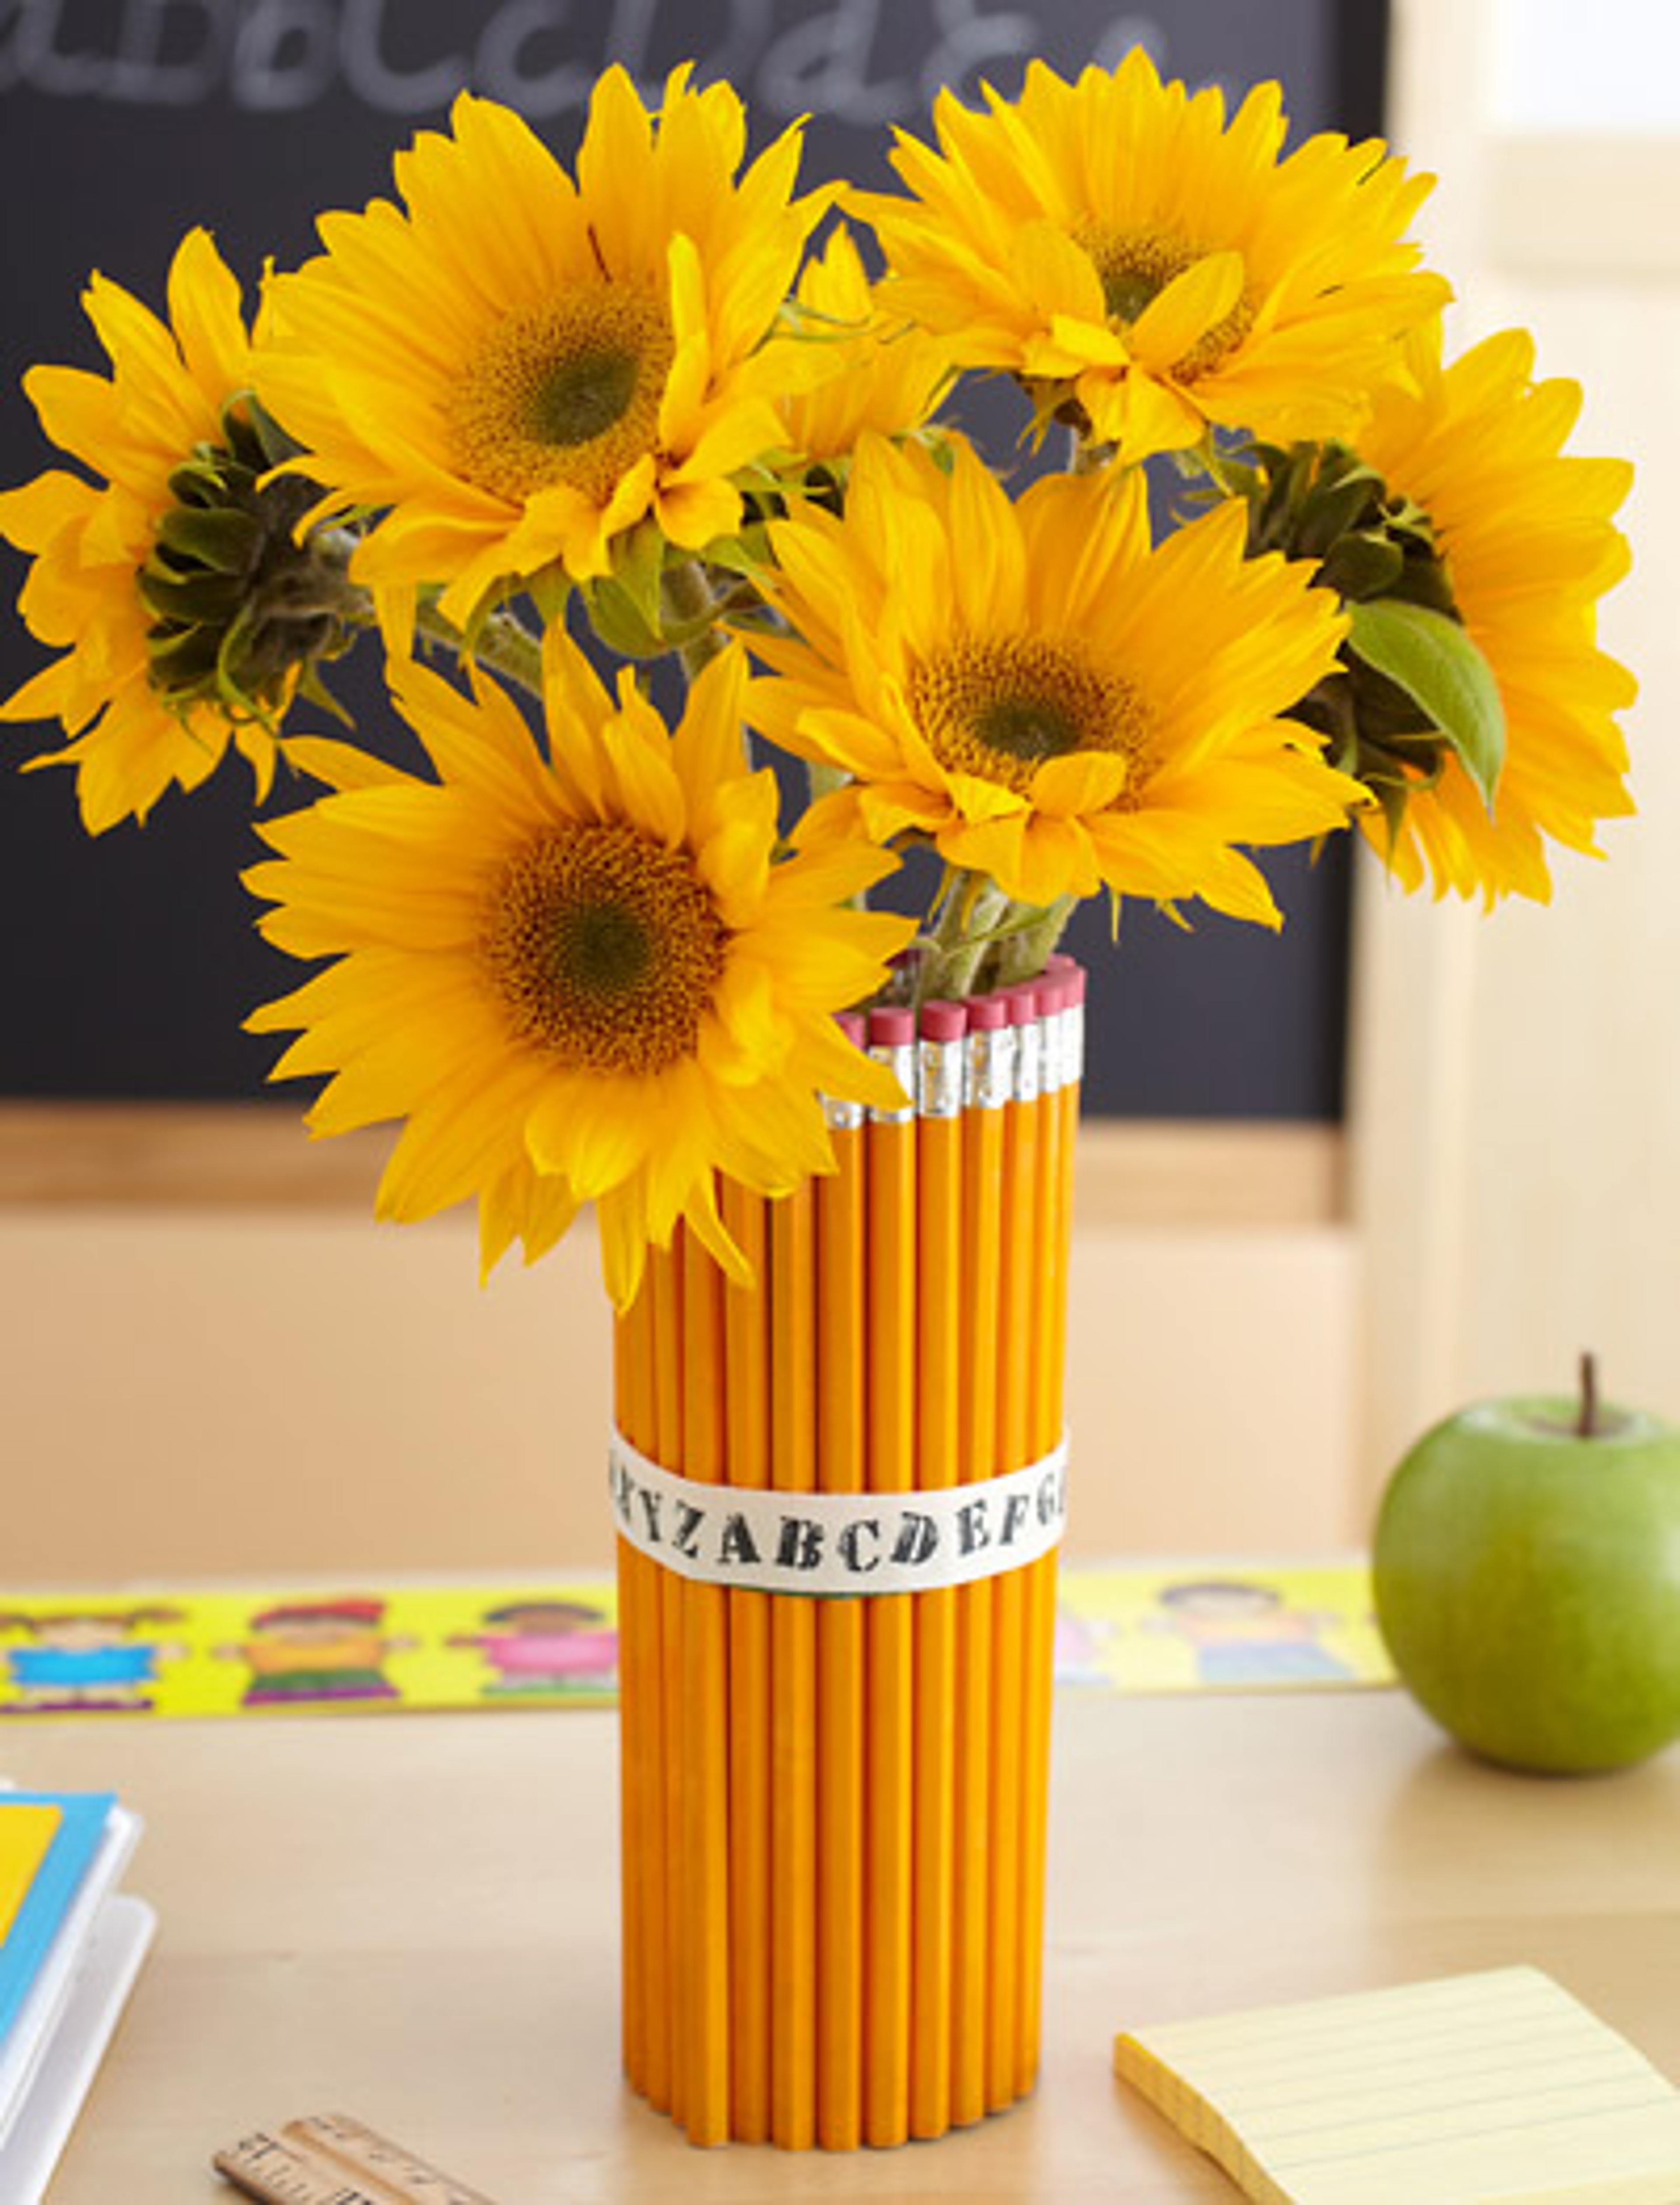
1349, 0, 1680, 1466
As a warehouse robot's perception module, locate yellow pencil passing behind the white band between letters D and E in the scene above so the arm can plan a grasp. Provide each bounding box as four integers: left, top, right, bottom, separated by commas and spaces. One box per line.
910, 1003, 968, 2137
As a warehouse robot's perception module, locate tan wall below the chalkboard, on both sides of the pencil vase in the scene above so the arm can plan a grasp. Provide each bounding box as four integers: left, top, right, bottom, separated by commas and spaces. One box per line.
0, 1113, 1362, 1588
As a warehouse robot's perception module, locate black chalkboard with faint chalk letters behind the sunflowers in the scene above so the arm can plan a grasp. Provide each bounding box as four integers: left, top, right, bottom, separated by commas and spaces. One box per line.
0, 0, 1387, 1118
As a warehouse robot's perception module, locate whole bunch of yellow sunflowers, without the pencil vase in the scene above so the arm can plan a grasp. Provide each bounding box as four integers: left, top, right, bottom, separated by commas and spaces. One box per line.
0, 51, 1631, 1308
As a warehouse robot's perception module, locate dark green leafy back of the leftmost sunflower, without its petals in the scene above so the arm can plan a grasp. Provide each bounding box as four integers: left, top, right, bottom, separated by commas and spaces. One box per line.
139, 395, 368, 725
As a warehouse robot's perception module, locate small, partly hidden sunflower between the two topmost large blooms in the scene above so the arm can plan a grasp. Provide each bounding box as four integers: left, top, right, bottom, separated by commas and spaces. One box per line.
780, 229, 950, 463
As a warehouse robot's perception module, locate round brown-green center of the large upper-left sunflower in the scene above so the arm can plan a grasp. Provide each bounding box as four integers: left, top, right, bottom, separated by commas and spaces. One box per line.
448, 278, 675, 505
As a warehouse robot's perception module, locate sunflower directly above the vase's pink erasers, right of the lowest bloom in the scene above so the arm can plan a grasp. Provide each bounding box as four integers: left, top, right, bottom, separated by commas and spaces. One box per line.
747, 439, 1365, 926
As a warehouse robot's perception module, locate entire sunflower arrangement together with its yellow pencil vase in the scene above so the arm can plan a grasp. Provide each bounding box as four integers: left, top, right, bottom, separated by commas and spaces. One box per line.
0, 53, 1634, 2148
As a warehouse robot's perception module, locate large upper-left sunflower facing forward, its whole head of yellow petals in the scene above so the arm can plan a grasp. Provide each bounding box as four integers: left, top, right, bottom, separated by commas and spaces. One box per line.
260, 68, 827, 637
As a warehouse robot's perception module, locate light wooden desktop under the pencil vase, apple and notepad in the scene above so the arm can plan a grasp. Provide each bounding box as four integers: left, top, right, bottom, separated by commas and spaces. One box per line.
7, 1691, 1680, 2205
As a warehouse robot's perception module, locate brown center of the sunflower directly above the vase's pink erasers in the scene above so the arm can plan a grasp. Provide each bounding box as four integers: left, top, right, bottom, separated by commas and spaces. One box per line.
906, 635, 1149, 794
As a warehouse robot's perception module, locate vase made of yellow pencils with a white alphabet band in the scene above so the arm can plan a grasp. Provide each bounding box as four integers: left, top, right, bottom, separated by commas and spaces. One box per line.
613, 961, 1082, 2150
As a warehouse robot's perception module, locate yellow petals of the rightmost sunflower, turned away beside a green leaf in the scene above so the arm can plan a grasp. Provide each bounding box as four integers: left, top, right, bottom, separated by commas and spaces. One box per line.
1358, 329, 1638, 906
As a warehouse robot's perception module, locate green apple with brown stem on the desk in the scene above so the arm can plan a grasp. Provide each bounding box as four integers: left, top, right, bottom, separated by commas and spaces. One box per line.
1371, 1363, 1680, 1773
